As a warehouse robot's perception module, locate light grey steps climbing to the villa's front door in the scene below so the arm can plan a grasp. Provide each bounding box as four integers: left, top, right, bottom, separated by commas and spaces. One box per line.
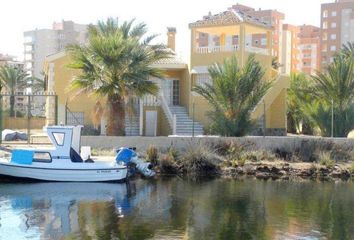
169, 106, 204, 136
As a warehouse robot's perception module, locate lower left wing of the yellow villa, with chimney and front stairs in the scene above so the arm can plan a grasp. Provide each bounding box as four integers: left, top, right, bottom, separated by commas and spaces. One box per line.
45, 28, 203, 136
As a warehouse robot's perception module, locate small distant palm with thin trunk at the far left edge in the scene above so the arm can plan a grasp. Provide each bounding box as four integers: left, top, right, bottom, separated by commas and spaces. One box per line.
0, 65, 31, 117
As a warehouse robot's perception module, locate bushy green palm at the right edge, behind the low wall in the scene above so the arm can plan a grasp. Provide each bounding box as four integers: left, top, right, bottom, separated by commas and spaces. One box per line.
307, 48, 354, 137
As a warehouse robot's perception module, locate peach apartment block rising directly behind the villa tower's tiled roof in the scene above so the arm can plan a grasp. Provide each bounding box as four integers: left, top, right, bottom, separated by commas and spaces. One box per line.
230, 4, 285, 63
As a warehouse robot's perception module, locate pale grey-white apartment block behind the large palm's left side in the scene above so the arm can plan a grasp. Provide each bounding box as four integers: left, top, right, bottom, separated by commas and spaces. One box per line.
23, 21, 87, 78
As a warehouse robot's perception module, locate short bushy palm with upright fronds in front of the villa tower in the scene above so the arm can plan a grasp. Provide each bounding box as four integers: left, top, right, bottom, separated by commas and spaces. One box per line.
194, 55, 272, 136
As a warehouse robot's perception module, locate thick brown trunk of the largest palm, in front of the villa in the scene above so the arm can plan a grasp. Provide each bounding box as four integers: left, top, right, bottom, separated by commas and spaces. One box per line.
107, 95, 125, 136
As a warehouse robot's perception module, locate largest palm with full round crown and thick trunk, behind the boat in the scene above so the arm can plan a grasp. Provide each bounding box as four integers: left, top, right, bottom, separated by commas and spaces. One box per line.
67, 18, 171, 135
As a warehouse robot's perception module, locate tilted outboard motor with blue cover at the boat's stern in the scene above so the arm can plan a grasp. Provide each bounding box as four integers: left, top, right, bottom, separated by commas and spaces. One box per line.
116, 147, 156, 177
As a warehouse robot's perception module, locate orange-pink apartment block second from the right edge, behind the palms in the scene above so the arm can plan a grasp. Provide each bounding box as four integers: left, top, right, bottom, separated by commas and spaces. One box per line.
298, 25, 321, 74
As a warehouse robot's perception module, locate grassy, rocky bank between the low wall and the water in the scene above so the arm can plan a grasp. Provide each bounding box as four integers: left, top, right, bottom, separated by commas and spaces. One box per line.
134, 140, 354, 179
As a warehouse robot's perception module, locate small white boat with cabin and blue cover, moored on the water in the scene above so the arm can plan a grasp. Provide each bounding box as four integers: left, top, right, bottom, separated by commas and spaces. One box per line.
0, 126, 127, 182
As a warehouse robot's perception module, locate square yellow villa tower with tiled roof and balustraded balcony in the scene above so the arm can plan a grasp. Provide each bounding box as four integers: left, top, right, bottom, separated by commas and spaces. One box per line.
189, 10, 290, 135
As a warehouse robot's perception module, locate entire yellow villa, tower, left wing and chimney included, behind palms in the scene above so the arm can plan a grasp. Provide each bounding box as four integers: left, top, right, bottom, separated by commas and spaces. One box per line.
44, 10, 289, 136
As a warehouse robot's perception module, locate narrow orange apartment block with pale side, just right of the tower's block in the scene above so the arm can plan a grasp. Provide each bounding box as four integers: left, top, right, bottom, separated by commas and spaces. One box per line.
280, 24, 299, 74
